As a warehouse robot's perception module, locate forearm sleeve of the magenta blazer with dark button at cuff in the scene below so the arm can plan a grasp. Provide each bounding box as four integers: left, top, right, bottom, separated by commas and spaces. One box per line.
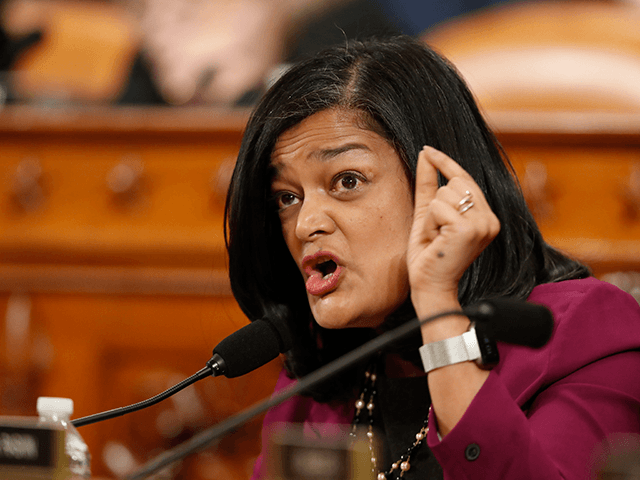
428, 352, 640, 480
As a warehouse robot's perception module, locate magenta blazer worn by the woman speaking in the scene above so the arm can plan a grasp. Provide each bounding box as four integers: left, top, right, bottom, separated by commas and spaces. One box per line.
252, 278, 640, 480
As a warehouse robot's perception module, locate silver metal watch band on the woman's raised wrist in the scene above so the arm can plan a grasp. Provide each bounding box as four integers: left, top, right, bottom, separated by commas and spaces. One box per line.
419, 326, 482, 373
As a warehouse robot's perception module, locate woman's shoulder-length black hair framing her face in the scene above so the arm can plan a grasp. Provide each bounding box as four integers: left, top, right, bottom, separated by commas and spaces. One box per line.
225, 37, 589, 400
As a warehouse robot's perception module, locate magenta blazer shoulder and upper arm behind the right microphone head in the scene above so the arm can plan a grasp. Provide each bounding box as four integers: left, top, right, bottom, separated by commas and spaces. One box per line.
496, 278, 640, 404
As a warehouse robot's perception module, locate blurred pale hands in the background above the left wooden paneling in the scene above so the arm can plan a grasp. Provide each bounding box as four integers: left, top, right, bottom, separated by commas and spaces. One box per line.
140, 0, 294, 104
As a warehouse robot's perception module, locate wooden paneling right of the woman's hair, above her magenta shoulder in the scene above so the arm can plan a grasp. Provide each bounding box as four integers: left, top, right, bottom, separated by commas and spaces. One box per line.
487, 111, 640, 276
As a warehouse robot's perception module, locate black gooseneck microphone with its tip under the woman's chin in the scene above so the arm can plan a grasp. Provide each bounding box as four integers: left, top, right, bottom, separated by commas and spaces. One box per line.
71, 314, 293, 427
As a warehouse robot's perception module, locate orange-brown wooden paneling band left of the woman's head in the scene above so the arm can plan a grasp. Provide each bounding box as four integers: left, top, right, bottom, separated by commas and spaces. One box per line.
0, 109, 245, 267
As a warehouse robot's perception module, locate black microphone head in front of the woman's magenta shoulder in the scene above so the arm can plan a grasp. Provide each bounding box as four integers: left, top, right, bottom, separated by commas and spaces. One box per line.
464, 298, 553, 348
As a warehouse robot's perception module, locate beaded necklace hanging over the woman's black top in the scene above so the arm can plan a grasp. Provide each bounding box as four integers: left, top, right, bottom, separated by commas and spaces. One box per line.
350, 362, 431, 480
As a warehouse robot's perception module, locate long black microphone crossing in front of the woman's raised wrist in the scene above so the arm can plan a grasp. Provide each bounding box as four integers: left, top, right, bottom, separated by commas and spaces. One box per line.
125, 298, 553, 480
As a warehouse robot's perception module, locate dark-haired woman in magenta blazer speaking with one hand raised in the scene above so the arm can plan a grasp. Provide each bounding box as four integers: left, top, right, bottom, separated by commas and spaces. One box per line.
226, 38, 640, 479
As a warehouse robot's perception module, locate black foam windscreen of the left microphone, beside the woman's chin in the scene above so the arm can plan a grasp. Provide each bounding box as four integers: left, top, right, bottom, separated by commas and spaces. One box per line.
213, 317, 293, 378
